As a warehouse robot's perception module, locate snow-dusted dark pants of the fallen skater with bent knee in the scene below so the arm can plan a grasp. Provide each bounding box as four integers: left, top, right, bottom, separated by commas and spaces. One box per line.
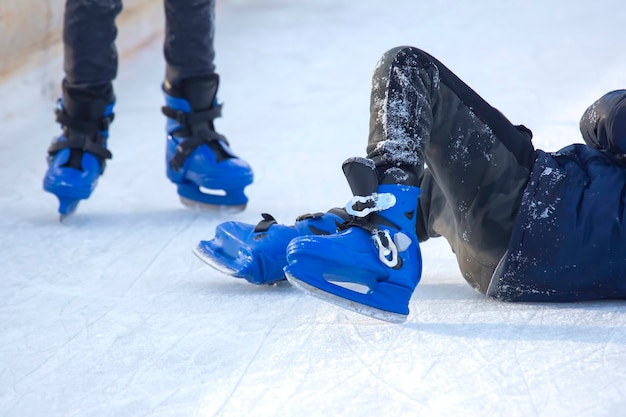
367, 47, 535, 293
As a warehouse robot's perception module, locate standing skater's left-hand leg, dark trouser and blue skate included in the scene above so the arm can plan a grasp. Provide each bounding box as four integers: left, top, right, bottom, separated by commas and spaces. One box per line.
44, 0, 122, 218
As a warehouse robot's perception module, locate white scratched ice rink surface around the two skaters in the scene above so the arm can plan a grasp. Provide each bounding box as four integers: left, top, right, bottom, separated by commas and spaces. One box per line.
0, 0, 626, 417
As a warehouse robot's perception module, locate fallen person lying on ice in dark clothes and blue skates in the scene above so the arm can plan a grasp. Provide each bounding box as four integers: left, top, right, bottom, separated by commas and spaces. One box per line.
194, 47, 626, 322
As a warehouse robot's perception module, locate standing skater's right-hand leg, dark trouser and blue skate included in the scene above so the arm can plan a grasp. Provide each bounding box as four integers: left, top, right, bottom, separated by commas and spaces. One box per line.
163, 0, 253, 210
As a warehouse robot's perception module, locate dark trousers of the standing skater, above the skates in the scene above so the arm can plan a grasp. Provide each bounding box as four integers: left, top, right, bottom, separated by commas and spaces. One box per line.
63, 0, 215, 89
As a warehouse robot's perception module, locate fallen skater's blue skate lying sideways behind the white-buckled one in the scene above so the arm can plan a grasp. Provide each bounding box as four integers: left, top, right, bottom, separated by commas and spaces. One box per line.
194, 209, 350, 284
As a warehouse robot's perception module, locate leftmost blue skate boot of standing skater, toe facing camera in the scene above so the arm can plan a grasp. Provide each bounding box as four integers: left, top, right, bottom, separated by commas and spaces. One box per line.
43, 81, 115, 220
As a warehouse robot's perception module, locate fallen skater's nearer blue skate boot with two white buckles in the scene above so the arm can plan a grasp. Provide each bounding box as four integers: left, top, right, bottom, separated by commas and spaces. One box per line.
285, 158, 422, 323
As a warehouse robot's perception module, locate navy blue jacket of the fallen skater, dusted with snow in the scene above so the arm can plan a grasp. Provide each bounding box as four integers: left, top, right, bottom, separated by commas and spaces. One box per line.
487, 90, 626, 302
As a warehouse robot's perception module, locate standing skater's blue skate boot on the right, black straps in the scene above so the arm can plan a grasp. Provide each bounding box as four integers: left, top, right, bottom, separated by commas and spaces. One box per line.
162, 74, 253, 211
